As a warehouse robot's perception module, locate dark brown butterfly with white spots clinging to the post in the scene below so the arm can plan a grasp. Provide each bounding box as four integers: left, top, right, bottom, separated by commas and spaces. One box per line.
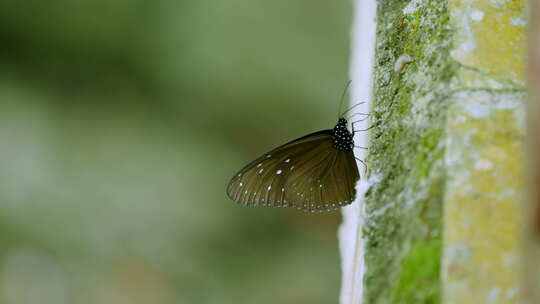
227, 118, 360, 212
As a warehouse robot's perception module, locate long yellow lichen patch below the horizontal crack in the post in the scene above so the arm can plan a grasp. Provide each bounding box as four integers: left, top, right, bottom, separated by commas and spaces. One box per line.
444, 109, 523, 303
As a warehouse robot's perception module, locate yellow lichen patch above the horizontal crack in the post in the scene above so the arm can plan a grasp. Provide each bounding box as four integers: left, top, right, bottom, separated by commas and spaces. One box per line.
451, 0, 526, 84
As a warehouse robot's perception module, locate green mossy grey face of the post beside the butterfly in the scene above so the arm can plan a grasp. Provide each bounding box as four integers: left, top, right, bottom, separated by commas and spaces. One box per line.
364, 0, 455, 304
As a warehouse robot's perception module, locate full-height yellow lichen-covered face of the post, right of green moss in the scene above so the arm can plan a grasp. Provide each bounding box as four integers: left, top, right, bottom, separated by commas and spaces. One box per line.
443, 0, 526, 304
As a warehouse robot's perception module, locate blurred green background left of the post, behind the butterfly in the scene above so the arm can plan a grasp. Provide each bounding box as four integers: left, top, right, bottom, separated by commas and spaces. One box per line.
0, 0, 351, 304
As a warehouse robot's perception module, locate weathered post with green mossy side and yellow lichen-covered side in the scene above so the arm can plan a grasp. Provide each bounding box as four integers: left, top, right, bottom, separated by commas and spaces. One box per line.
346, 0, 526, 304
